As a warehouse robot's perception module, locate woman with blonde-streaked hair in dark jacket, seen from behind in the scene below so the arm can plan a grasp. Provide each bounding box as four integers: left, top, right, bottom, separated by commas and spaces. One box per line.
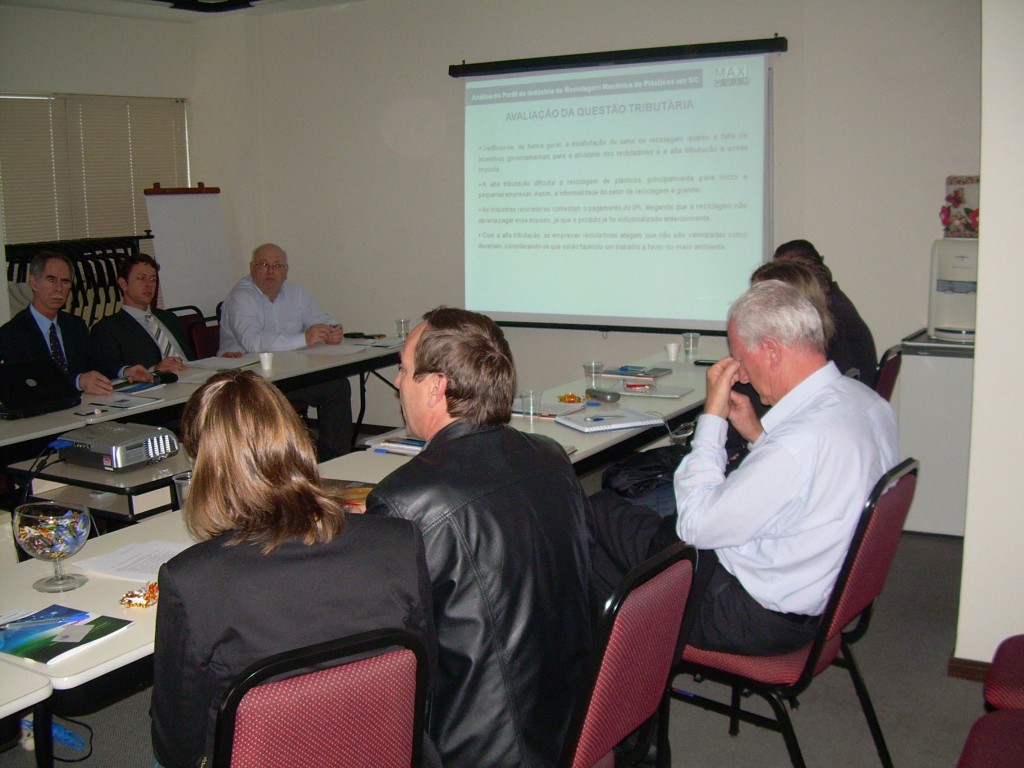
152, 371, 436, 768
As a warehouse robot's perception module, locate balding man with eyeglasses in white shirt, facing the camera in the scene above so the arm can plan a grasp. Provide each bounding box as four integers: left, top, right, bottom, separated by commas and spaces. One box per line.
218, 243, 352, 461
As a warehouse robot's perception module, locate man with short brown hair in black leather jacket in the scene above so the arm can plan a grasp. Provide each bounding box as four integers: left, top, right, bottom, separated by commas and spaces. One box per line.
367, 307, 591, 768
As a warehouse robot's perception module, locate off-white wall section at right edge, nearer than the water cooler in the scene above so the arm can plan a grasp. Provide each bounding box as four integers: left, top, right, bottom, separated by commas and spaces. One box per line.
955, 0, 1024, 662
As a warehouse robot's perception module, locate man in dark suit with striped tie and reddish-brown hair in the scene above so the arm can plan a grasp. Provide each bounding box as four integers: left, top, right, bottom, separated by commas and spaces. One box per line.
92, 253, 196, 381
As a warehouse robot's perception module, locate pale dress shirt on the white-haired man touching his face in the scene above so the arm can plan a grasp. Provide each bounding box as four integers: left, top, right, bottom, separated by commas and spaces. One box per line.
675, 362, 899, 615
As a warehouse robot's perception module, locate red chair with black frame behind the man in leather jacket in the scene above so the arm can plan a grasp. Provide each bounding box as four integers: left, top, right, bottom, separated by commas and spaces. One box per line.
558, 542, 695, 768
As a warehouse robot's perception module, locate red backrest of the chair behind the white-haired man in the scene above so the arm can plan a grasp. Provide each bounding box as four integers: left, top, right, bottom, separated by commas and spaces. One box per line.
808, 459, 919, 674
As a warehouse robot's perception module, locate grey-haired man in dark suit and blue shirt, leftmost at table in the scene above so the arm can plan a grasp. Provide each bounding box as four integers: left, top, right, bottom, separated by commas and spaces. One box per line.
0, 251, 114, 395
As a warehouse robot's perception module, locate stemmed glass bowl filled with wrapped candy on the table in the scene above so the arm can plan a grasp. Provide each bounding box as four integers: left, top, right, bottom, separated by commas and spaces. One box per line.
14, 502, 92, 592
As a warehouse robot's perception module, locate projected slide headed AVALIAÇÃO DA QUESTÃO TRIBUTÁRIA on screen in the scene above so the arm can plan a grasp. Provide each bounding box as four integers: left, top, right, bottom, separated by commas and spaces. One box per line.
465, 55, 767, 328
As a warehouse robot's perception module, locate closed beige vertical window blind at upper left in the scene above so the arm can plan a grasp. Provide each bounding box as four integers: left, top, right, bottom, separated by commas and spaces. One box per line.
0, 95, 188, 244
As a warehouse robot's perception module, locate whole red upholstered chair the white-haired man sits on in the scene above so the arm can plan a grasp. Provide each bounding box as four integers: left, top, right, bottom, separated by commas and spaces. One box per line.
673, 459, 918, 768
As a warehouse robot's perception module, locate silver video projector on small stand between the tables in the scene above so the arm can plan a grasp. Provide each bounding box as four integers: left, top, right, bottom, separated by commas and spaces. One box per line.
59, 422, 178, 471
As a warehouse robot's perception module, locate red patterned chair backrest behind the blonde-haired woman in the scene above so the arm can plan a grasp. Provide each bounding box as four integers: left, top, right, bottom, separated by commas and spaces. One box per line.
213, 630, 427, 768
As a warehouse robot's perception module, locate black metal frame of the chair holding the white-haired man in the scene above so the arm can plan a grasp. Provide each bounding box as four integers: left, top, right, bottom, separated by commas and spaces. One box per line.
671, 459, 920, 768
